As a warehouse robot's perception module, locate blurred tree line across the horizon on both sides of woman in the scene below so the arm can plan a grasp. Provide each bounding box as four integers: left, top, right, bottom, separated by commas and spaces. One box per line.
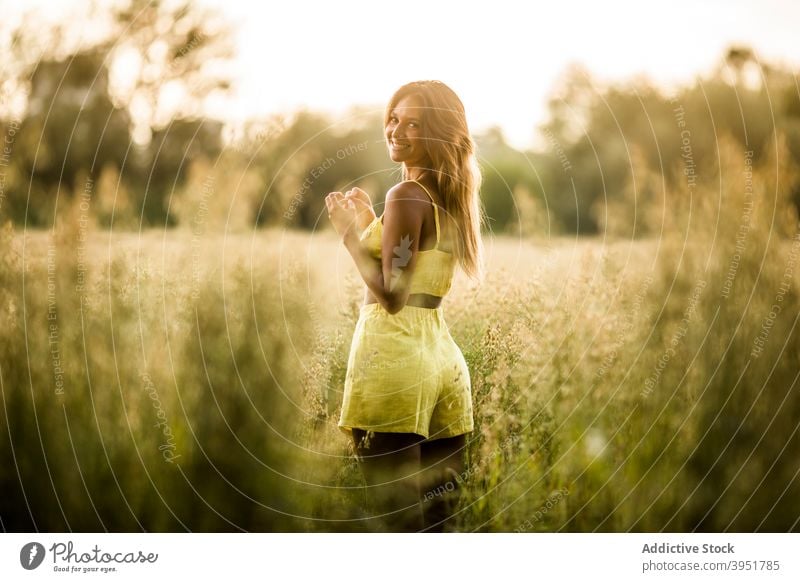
0, 0, 800, 239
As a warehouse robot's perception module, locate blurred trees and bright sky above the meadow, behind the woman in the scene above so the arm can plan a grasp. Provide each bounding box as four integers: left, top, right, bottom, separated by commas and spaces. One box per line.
0, 0, 800, 236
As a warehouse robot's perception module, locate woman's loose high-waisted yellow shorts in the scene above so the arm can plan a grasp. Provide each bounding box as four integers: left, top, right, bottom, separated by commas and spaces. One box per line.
339, 303, 474, 440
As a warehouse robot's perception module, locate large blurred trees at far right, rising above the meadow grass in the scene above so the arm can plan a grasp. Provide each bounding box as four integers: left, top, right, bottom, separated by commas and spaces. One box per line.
540, 46, 800, 236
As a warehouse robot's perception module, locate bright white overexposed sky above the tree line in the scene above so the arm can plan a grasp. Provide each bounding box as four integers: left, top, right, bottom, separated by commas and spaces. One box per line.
0, 0, 800, 147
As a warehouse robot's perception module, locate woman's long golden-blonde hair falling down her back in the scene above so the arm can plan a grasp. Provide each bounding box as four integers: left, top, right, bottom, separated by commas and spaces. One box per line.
384, 81, 485, 281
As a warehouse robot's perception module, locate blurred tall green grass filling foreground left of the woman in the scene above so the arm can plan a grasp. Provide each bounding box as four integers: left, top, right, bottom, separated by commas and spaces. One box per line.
0, 227, 318, 531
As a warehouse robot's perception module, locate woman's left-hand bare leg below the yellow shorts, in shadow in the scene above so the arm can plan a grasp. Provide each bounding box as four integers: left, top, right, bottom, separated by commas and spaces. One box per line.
353, 428, 424, 532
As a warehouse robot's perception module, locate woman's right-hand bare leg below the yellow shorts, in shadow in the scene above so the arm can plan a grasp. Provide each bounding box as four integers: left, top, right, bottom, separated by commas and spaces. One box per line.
420, 435, 467, 532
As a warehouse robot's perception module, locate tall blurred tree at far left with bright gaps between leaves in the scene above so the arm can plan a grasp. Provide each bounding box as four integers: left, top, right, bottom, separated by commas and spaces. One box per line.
0, 0, 232, 226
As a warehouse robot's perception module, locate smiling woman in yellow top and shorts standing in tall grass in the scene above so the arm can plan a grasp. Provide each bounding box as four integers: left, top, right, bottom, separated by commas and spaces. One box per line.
325, 81, 483, 531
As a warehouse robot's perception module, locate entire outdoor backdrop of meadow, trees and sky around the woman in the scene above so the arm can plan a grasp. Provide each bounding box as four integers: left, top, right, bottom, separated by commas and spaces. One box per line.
0, 0, 800, 531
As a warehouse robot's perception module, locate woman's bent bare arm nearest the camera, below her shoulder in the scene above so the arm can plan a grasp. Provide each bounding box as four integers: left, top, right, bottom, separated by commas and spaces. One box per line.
343, 182, 427, 314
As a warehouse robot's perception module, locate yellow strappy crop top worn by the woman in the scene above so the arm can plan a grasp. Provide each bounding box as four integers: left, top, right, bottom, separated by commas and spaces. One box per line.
360, 180, 456, 297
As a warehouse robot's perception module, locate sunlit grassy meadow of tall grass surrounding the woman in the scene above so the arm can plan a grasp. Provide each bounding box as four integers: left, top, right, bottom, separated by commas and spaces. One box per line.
0, 138, 800, 532
